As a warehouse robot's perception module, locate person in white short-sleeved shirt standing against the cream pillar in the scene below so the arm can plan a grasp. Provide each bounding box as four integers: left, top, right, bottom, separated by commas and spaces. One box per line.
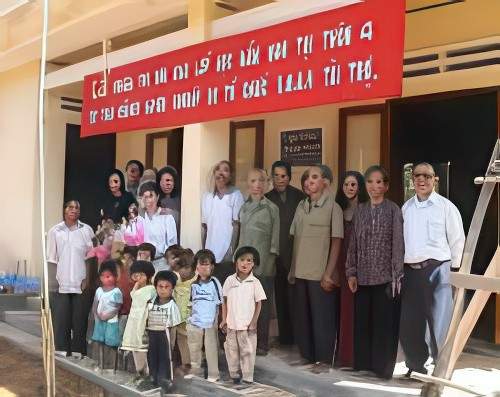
201, 160, 244, 284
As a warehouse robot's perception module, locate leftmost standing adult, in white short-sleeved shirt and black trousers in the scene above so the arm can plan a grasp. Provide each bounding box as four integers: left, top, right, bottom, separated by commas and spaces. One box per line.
47, 200, 97, 356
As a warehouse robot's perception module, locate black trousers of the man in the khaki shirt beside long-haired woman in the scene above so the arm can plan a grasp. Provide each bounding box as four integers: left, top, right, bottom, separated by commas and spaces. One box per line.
293, 278, 339, 364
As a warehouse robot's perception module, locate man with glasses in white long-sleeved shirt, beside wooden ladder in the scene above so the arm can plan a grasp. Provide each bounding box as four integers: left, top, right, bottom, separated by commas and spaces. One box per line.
400, 163, 465, 376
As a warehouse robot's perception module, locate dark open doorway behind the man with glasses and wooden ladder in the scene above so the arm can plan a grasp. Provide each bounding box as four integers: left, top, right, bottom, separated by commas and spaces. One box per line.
390, 90, 498, 341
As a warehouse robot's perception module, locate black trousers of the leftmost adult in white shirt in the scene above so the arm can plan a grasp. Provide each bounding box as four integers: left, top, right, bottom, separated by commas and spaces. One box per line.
51, 289, 95, 355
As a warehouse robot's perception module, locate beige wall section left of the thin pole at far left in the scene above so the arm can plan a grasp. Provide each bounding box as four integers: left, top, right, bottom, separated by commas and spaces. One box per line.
0, 62, 41, 274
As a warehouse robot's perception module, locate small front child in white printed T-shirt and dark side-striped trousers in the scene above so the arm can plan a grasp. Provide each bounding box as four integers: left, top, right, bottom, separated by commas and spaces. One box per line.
147, 270, 181, 390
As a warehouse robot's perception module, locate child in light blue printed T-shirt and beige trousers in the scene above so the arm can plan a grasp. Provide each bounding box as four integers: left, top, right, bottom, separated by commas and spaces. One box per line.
187, 250, 222, 381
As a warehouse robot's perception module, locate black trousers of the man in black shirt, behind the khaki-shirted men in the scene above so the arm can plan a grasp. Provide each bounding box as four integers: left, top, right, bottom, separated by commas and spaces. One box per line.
274, 257, 293, 345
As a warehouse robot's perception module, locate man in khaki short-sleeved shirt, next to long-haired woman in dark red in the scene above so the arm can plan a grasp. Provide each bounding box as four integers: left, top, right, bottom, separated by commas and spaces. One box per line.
289, 167, 344, 364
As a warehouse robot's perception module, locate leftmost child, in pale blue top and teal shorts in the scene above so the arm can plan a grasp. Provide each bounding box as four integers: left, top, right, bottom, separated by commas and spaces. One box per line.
92, 260, 123, 358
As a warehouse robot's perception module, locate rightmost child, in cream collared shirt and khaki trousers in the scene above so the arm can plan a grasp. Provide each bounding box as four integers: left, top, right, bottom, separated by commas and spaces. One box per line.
220, 246, 267, 384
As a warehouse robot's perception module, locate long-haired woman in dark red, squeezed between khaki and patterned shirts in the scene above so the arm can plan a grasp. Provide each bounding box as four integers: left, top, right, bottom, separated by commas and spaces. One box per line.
335, 171, 368, 367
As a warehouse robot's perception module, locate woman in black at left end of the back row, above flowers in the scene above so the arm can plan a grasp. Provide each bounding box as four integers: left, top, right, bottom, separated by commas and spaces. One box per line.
101, 169, 136, 223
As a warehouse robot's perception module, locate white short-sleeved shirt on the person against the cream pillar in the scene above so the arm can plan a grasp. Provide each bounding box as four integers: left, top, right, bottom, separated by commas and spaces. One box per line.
201, 189, 244, 263
